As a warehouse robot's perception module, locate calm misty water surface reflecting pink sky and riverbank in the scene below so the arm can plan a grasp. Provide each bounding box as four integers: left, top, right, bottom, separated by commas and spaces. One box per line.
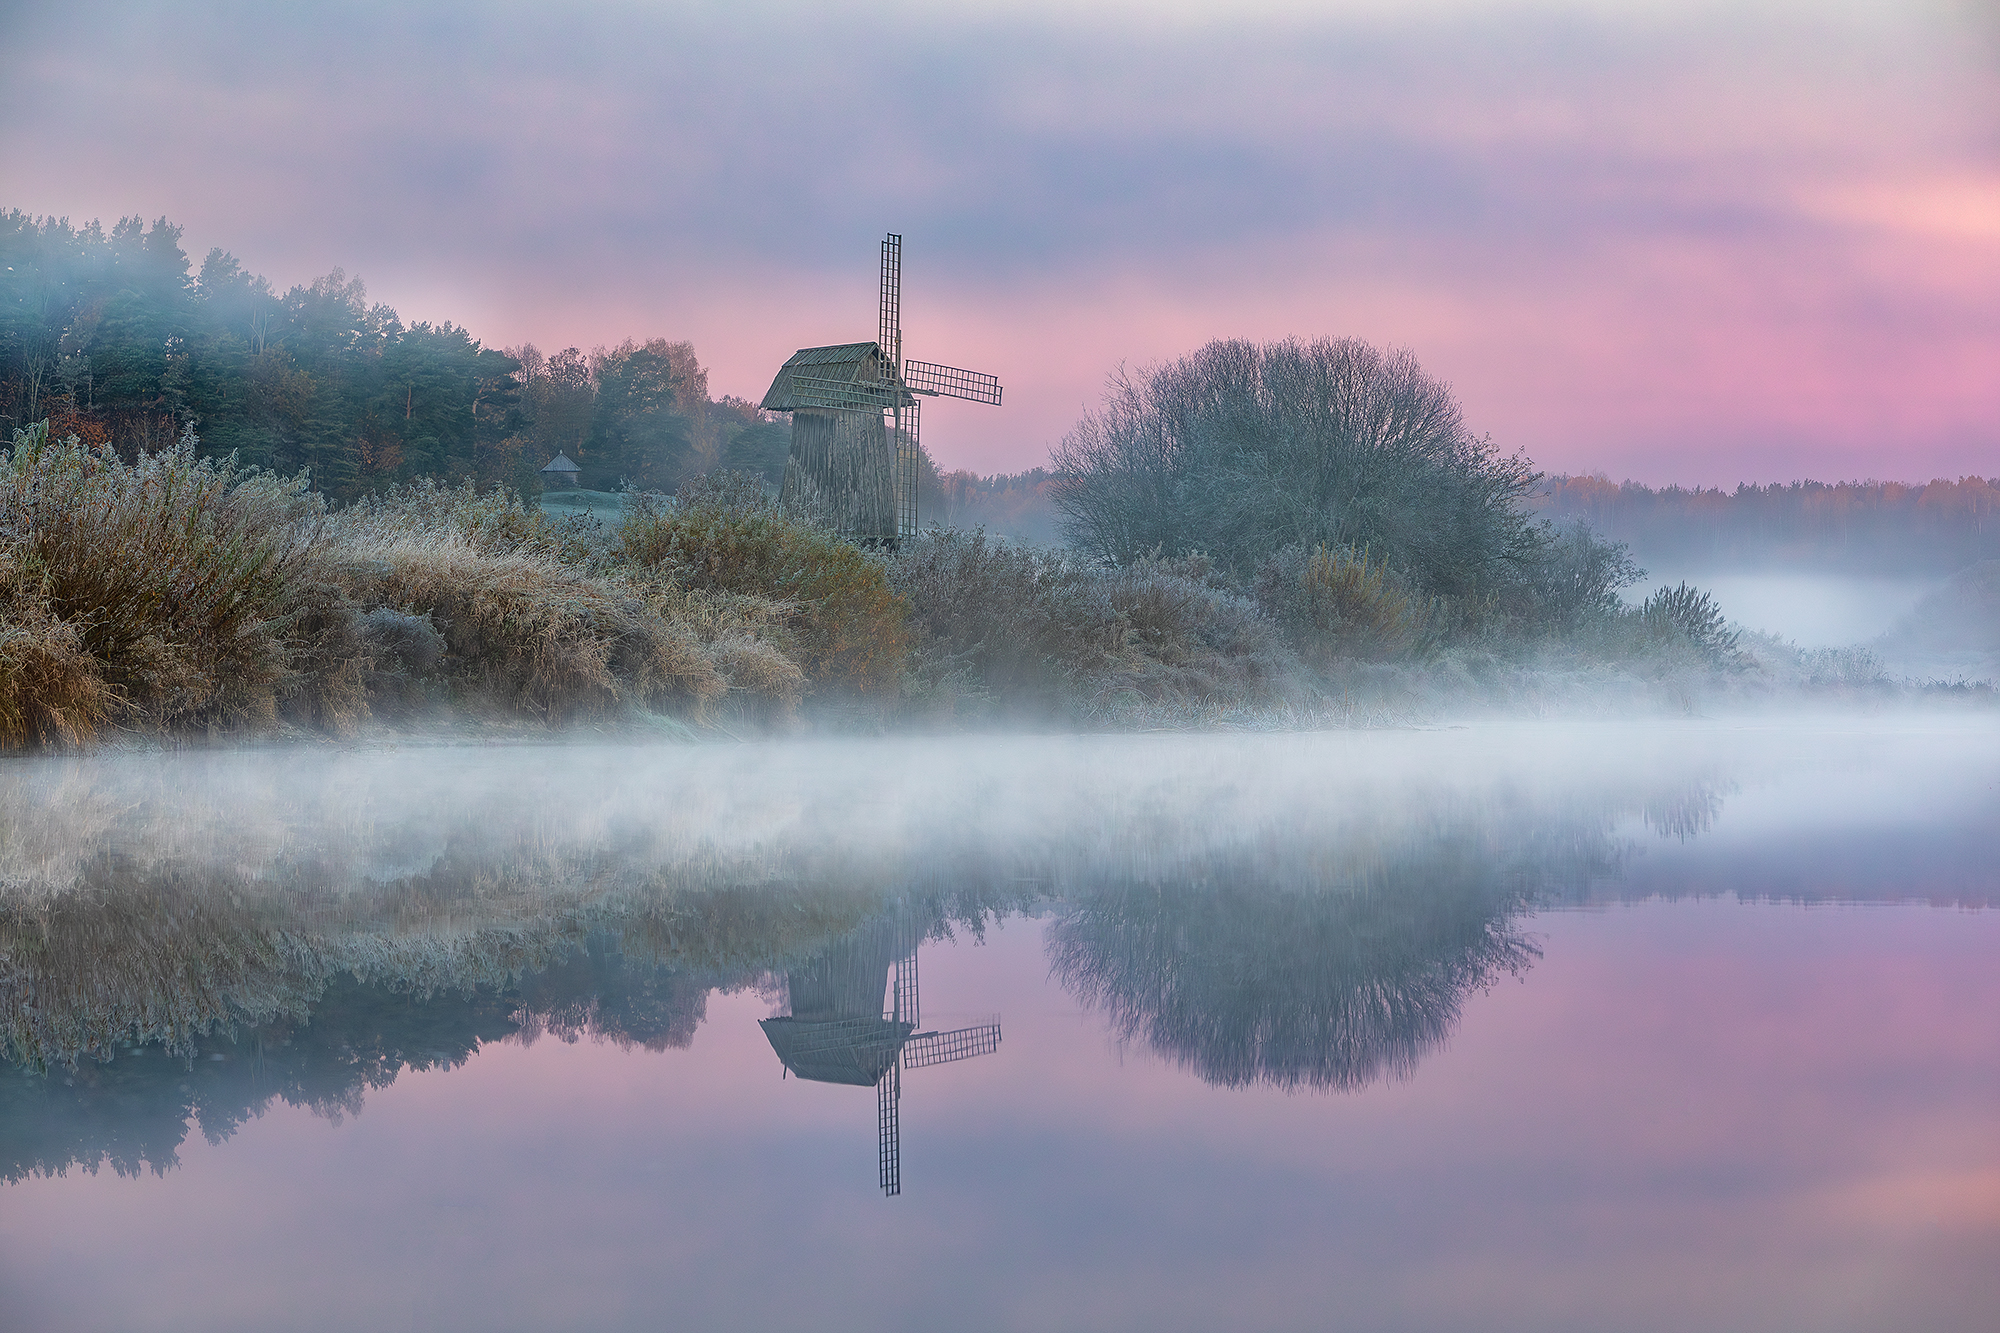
0, 717, 2000, 1331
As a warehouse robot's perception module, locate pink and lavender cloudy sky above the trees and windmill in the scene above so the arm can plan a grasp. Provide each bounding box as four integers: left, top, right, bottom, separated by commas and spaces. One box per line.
0, 0, 2000, 484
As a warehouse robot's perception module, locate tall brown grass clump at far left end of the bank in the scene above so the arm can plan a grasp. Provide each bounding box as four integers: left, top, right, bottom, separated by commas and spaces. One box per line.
0, 422, 326, 745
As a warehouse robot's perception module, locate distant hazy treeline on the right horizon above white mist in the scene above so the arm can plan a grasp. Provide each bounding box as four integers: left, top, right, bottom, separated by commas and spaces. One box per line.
1534, 476, 2000, 572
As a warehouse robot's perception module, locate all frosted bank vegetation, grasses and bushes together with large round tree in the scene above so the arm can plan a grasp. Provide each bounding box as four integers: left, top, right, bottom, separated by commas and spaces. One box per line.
0, 340, 1992, 747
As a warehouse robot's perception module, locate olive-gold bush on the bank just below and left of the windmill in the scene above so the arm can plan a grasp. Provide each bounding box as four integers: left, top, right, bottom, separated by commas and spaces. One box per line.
610, 474, 910, 699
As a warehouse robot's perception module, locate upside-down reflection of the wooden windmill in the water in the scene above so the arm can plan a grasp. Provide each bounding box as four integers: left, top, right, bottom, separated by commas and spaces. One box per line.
762, 919, 1000, 1195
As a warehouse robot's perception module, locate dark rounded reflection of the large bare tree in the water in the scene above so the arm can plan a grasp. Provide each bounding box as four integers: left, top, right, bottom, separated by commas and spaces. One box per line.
1046, 845, 1540, 1091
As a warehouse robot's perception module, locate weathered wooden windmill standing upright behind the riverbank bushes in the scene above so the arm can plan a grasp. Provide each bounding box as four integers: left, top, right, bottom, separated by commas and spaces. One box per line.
760, 232, 1000, 544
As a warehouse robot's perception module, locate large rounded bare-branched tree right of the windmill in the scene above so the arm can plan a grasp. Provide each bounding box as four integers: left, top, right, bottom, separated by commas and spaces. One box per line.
1052, 338, 1536, 594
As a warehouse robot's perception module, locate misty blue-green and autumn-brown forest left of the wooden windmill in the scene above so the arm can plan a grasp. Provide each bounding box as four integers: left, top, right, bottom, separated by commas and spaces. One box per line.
0, 210, 788, 498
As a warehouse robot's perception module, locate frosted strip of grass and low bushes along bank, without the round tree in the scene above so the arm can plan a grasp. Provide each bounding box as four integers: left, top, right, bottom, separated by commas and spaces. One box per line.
0, 418, 1992, 749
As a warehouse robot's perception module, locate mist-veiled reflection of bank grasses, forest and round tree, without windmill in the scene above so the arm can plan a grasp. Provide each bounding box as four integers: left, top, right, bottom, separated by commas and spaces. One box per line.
0, 741, 1978, 1179
